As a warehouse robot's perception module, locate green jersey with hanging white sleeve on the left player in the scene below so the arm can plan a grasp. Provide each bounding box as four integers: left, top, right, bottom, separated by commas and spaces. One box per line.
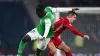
36, 7, 54, 38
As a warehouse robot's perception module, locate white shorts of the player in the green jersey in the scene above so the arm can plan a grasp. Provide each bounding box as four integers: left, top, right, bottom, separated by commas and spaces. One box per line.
27, 28, 50, 50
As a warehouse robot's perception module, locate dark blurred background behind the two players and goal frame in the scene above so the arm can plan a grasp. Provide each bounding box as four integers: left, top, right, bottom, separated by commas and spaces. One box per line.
0, 0, 100, 56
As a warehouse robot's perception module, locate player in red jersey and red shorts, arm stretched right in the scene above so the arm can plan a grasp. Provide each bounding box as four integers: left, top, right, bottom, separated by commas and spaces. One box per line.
48, 10, 89, 56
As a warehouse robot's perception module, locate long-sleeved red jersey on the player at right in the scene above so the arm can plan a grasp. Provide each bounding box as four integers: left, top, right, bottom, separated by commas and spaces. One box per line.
54, 17, 84, 37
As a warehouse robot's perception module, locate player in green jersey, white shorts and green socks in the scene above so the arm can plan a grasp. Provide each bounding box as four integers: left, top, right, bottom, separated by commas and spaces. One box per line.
17, 5, 54, 56
